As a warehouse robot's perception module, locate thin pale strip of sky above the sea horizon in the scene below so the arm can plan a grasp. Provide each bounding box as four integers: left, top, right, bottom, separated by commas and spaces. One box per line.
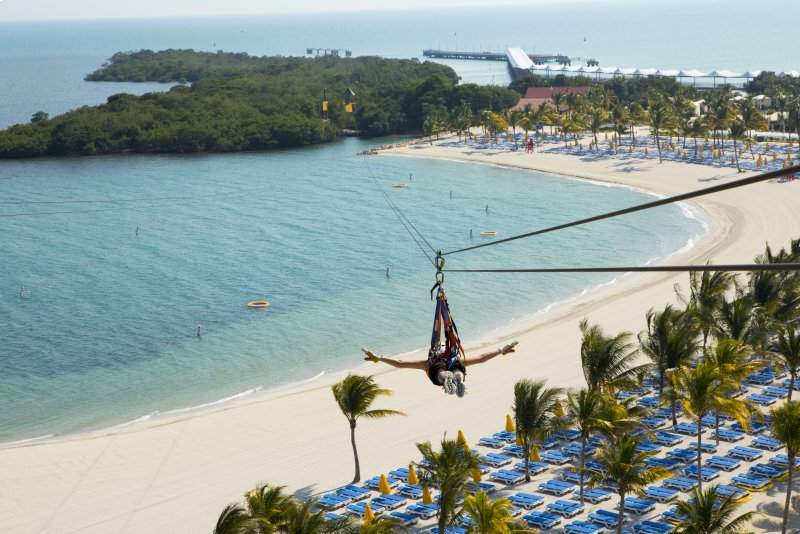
0, 0, 604, 21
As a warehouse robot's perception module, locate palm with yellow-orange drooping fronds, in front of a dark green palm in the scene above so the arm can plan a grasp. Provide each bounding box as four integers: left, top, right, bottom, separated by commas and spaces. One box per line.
672, 362, 750, 487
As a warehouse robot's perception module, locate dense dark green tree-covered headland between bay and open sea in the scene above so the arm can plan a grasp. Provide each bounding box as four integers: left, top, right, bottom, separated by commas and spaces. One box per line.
0, 50, 519, 158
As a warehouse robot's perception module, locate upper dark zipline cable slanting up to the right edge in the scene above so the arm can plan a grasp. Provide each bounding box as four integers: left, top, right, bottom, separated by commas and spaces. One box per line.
442, 165, 800, 258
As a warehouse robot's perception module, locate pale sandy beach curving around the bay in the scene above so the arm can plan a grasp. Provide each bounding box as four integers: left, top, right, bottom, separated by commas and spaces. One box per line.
0, 145, 800, 534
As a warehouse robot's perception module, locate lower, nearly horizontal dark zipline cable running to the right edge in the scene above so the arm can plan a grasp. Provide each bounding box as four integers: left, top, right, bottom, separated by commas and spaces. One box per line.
444, 263, 800, 273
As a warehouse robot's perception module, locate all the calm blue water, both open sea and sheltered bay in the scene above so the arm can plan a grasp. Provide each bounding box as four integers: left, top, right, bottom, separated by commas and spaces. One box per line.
0, 1, 780, 441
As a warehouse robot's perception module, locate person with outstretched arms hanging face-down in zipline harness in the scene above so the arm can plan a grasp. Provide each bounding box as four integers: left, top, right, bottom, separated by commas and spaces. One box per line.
361, 282, 517, 397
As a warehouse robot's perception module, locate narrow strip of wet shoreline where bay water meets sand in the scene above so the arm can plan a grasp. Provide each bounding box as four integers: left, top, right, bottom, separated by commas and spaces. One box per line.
0, 156, 711, 451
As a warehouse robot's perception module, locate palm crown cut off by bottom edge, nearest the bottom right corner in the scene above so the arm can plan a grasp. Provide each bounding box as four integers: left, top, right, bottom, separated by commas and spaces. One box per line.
676, 485, 755, 534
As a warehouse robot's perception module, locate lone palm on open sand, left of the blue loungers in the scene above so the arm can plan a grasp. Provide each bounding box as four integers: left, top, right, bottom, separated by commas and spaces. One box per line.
331, 375, 405, 483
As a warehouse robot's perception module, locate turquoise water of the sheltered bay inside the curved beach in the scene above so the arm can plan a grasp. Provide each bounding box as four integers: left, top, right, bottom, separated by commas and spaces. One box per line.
0, 139, 700, 440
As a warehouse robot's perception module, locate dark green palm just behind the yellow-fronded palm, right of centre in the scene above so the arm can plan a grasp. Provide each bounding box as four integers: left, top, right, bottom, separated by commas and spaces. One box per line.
639, 304, 700, 426
